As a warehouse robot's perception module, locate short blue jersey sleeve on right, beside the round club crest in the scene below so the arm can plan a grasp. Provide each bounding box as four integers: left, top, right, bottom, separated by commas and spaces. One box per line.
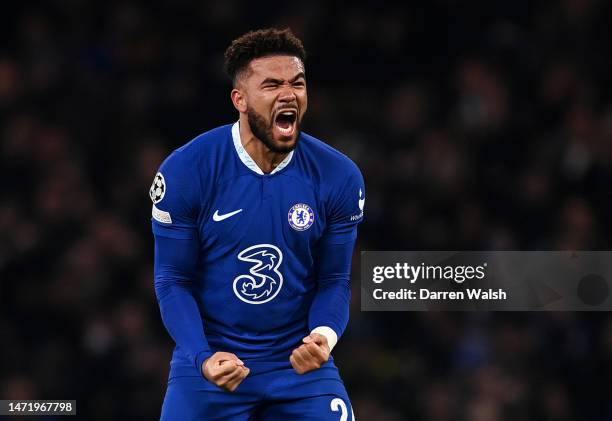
324, 162, 365, 244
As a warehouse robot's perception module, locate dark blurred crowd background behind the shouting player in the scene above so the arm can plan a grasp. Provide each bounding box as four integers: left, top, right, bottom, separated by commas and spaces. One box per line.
0, 0, 612, 421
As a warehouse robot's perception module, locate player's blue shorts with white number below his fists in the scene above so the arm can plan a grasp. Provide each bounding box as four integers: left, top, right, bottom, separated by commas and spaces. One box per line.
161, 365, 355, 421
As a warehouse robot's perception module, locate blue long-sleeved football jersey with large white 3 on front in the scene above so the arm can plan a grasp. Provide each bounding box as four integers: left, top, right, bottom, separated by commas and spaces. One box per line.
150, 123, 365, 372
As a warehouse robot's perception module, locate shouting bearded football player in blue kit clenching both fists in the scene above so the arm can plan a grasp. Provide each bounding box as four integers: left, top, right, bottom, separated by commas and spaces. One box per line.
150, 29, 365, 421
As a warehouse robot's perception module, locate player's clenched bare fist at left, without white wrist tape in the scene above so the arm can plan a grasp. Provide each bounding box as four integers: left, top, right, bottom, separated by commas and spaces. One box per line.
202, 352, 251, 392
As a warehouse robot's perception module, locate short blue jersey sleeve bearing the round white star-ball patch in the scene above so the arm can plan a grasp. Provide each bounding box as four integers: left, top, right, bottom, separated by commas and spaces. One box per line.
149, 150, 200, 240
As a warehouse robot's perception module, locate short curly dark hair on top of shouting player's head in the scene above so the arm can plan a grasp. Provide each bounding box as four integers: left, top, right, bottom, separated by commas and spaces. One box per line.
225, 28, 306, 85
